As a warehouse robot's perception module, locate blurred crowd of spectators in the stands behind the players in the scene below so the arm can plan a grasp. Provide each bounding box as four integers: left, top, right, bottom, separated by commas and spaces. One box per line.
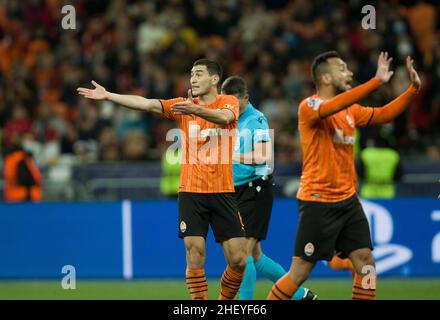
0, 0, 440, 186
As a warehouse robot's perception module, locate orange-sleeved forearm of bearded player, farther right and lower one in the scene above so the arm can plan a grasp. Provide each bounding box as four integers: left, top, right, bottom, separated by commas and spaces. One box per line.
370, 85, 417, 125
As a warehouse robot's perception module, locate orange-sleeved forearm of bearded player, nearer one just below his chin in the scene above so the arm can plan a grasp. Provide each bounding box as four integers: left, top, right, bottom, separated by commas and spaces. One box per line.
319, 77, 381, 118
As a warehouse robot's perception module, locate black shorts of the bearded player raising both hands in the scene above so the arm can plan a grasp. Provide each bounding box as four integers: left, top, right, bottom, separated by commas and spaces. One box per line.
295, 195, 373, 261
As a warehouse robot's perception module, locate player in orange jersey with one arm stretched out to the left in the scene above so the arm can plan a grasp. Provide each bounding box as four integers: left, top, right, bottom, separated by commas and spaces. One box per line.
77, 59, 246, 300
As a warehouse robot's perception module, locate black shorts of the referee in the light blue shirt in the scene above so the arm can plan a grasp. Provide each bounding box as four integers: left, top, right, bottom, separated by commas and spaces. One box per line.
235, 176, 274, 240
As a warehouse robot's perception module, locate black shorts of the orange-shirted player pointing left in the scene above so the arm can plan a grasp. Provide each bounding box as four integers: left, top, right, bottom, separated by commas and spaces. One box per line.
178, 192, 245, 242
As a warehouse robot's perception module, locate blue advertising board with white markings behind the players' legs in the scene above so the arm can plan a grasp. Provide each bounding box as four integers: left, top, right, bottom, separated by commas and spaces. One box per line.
0, 199, 440, 279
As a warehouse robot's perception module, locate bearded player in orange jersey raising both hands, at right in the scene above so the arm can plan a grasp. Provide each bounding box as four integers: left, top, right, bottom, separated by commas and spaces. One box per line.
268, 51, 421, 300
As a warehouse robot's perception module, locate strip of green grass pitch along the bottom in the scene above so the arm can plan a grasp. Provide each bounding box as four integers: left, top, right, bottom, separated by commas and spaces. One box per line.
0, 278, 440, 300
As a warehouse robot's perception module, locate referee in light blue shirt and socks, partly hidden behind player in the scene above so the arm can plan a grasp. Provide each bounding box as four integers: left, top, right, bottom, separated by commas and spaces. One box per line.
221, 76, 316, 300
